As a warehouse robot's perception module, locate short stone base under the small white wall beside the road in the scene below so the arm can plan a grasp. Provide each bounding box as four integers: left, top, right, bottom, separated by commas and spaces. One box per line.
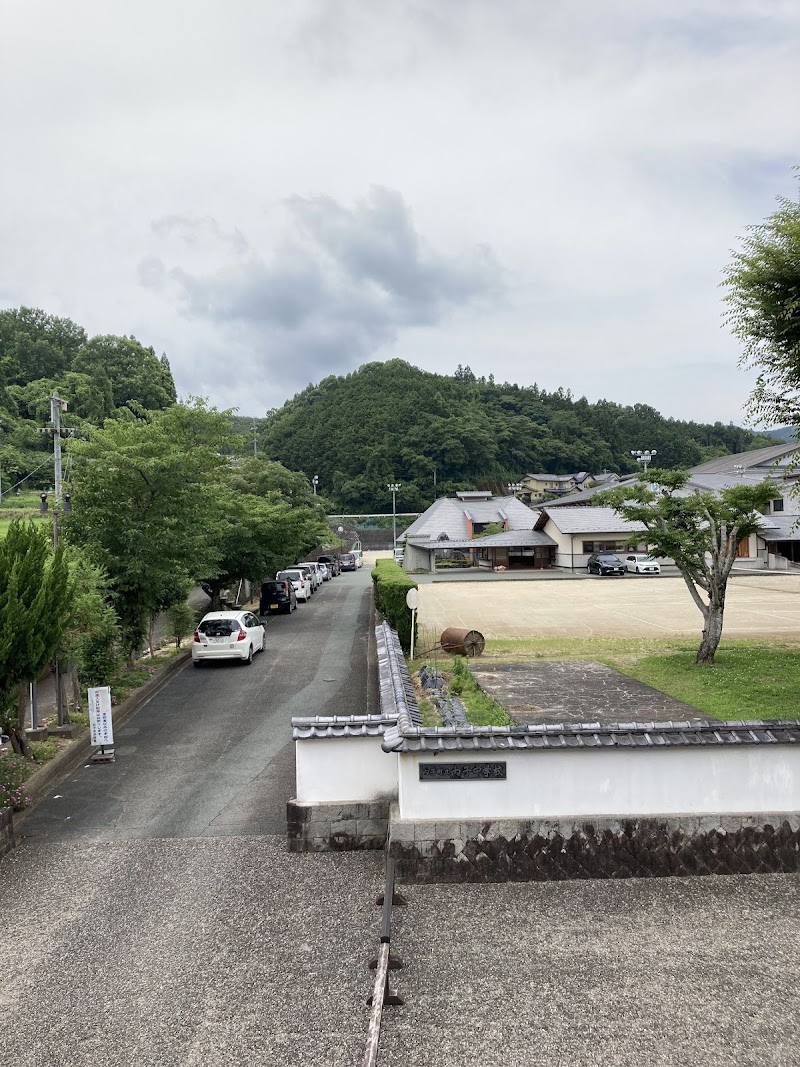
286, 800, 389, 853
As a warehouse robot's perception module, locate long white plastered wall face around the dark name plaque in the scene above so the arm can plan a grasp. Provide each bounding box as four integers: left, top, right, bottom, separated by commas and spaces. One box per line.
399, 745, 800, 821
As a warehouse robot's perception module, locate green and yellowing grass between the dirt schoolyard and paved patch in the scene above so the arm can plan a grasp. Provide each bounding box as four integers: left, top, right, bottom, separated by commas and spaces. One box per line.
411, 636, 800, 719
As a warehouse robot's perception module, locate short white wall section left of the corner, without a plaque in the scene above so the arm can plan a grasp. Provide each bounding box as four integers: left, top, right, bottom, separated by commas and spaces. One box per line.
294, 736, 397, 803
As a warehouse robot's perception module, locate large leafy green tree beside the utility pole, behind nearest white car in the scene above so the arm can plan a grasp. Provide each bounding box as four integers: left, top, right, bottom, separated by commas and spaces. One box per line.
63, 400, 235, 656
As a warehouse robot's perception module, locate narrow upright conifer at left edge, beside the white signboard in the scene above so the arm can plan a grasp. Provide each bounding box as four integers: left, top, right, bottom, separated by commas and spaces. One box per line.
0, 521, 75, 755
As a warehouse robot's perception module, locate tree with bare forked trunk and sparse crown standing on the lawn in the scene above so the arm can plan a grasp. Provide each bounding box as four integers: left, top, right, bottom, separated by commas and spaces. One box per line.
594, 469, 775, 664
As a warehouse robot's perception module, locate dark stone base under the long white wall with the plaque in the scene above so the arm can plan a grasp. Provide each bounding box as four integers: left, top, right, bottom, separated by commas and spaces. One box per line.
389, 803, 800, 882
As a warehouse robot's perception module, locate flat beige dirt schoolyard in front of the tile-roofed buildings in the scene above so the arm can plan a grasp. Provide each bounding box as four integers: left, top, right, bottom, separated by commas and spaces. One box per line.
419, 573, 800, 640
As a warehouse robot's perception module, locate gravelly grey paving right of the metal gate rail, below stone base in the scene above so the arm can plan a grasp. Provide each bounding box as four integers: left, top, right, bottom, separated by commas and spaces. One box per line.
380, 875, 800, 1067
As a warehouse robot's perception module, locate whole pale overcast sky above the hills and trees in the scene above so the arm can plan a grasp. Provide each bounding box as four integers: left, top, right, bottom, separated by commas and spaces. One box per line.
0, 0, 800, 423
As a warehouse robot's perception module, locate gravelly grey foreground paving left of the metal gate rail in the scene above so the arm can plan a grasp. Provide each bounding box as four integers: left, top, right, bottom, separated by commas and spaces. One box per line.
0, 837, 383, 1067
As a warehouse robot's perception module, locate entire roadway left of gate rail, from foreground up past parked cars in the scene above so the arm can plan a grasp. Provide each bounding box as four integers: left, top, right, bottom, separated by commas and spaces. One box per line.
0, 569, 382, 1067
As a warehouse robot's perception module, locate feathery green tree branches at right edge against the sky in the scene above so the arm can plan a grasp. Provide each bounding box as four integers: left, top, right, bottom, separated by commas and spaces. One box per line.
724, 185, 800, 426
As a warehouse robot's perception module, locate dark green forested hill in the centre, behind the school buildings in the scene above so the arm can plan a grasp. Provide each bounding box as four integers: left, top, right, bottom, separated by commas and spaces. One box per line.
259, 360, 772, 512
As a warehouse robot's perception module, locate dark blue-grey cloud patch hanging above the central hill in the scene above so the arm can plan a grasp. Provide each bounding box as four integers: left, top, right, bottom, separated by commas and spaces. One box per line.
139, 187, 503, 383
